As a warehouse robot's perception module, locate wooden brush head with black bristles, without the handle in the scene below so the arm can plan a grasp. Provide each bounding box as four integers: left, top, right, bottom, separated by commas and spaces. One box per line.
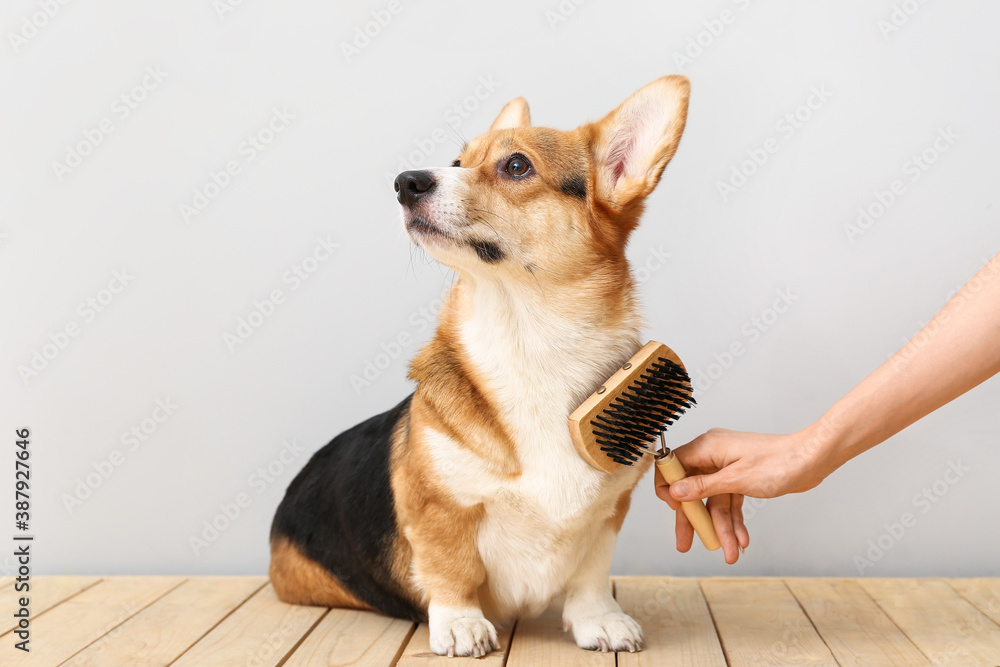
569, 341, 695, 472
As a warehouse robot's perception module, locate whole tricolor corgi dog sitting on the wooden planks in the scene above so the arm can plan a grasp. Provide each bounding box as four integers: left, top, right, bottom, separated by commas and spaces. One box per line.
270, 75, 690, 656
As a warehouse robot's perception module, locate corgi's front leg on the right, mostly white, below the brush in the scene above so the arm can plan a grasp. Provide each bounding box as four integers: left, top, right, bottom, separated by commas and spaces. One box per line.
563, 523, 642, 651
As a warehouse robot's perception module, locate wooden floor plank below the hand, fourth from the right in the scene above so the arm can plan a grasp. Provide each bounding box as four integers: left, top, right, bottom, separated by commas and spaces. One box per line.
701, 579, 837, 667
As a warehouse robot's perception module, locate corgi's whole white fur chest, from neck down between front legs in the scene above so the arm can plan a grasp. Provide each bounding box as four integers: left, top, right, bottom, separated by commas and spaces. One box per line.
433, 280, 644, 616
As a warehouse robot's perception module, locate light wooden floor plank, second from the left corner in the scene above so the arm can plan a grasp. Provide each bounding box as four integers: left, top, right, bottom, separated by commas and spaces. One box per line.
3, 577, 184, 667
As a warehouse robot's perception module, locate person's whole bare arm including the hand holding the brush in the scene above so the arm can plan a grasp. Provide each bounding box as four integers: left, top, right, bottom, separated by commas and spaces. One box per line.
656, 249, 1000, 560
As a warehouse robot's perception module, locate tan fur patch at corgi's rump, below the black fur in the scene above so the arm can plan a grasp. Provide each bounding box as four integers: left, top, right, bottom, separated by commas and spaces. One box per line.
268, 540, 369, 609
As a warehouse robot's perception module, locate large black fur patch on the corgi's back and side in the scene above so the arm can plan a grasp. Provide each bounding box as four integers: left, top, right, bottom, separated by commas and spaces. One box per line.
271, 394, 426, 621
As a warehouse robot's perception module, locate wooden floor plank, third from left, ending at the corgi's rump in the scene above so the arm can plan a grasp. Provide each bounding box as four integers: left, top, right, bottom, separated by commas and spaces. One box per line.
59, 577, 267, 667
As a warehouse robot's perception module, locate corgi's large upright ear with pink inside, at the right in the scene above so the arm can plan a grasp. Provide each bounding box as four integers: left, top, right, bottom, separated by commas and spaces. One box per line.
591, 74, 691, 210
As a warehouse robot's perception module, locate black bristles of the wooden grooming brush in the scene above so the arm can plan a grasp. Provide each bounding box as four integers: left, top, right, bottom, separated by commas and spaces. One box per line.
590, 357, 696, 465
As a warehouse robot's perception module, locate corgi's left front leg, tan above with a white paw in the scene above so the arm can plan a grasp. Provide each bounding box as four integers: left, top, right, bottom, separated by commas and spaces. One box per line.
407, 502, 500, 658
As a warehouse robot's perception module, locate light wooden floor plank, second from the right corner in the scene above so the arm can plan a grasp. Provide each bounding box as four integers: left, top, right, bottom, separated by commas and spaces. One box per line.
860, 579, 1000, 667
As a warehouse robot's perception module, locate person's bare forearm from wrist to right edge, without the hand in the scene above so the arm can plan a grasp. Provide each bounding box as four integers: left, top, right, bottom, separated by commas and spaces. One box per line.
808, 255, 1000, 473
